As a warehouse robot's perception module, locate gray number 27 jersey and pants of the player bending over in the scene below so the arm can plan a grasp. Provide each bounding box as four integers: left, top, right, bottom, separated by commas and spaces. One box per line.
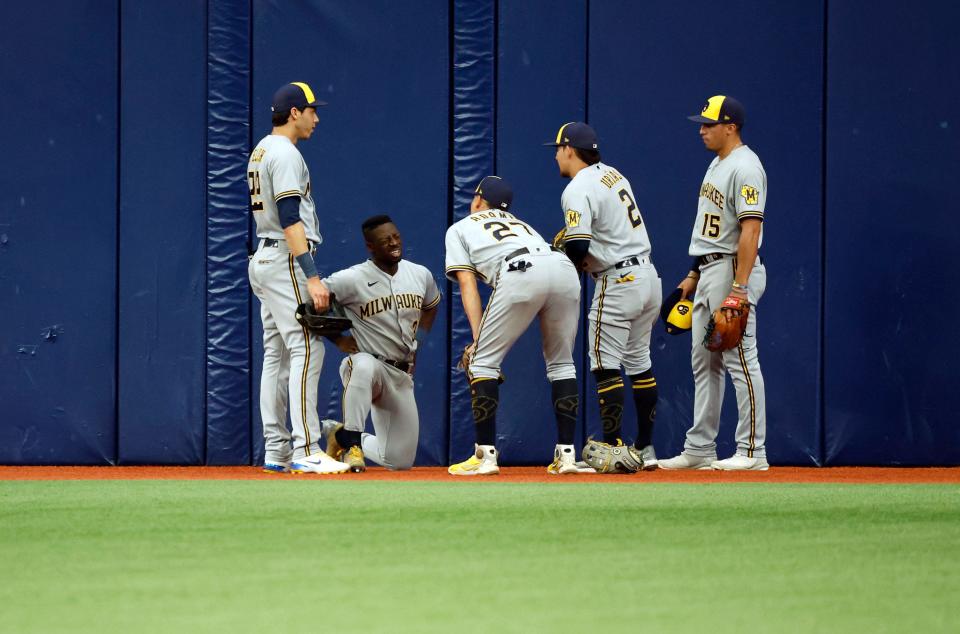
446, 210, 580, 381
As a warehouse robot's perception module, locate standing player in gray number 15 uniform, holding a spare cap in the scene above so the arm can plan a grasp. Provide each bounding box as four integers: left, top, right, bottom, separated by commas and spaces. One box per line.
660, 95, 769, 471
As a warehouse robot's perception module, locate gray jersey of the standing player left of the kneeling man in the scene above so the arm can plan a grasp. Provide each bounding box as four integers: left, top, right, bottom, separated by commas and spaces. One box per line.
247, 134, 323, 244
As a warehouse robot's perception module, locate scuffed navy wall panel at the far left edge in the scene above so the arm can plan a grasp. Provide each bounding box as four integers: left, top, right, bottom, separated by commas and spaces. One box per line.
0, 1, 117, 464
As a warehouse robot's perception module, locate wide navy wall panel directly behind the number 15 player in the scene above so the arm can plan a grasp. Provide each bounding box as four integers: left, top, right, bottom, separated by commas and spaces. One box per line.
587, 0, 823, 464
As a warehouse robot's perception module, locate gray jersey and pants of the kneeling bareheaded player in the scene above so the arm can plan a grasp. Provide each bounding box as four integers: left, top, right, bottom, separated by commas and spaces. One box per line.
325, 260, 440, 469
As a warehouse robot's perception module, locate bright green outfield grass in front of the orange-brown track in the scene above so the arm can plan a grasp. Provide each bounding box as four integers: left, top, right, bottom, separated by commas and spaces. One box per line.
0, 478, 960, 634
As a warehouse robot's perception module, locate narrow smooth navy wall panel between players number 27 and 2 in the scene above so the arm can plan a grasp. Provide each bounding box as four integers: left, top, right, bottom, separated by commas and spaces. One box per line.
492, 0, 589, 465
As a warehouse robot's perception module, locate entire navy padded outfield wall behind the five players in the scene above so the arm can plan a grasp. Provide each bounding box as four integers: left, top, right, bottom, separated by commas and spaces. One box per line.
0, 0, 960, 465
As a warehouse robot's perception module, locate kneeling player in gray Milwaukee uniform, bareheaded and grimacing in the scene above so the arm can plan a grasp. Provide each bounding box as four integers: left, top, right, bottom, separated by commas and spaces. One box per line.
323, 215, 440, 473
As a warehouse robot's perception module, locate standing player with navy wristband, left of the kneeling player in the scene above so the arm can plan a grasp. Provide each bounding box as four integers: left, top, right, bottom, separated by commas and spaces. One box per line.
247, 82, 348, 473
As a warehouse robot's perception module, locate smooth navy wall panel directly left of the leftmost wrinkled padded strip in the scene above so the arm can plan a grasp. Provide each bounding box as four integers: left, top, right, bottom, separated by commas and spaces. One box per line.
118, 0, 207, 464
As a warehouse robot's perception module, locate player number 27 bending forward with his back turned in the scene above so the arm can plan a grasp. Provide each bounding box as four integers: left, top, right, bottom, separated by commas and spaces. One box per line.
446, 176, 581, 476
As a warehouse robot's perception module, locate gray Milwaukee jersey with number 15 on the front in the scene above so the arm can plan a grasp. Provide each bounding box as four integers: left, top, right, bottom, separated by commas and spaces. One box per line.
690, 145, 767, 256
